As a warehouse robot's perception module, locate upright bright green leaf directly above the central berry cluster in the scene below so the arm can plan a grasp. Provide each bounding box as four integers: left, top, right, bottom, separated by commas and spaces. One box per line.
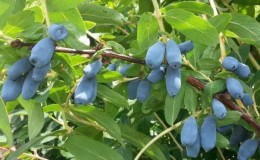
137, 13, 159, 50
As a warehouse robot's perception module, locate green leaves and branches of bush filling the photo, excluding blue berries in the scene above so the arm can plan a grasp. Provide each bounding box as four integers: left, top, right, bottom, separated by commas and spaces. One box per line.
0, 0, 260, 160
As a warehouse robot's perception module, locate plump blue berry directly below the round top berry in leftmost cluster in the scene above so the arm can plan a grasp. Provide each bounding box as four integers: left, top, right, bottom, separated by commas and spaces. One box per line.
30, 38, 55, 67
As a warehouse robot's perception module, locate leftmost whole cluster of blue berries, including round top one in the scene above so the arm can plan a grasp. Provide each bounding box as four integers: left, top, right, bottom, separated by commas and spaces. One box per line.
1, 24, 68, 102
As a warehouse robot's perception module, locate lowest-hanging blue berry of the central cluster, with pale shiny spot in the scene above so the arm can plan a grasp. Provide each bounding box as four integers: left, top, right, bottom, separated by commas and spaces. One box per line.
165, 66, 181, 96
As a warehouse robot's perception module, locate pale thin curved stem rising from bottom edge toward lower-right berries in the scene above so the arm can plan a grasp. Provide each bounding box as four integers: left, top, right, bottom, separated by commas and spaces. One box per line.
134, 122, 182, 160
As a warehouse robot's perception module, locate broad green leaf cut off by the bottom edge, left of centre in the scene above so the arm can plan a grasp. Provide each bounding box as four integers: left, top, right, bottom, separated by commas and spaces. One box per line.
64, 135, 123, 160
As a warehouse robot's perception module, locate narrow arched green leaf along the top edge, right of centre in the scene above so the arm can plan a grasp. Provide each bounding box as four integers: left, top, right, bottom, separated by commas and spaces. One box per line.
163, 1, 213, 16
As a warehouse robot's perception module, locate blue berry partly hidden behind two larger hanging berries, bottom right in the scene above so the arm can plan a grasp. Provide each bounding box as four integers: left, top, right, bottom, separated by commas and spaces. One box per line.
186, 128, 200, 158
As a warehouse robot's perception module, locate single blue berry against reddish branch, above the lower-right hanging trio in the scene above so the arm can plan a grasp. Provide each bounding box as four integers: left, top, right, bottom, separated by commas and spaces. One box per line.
212, 98, 227, 119
